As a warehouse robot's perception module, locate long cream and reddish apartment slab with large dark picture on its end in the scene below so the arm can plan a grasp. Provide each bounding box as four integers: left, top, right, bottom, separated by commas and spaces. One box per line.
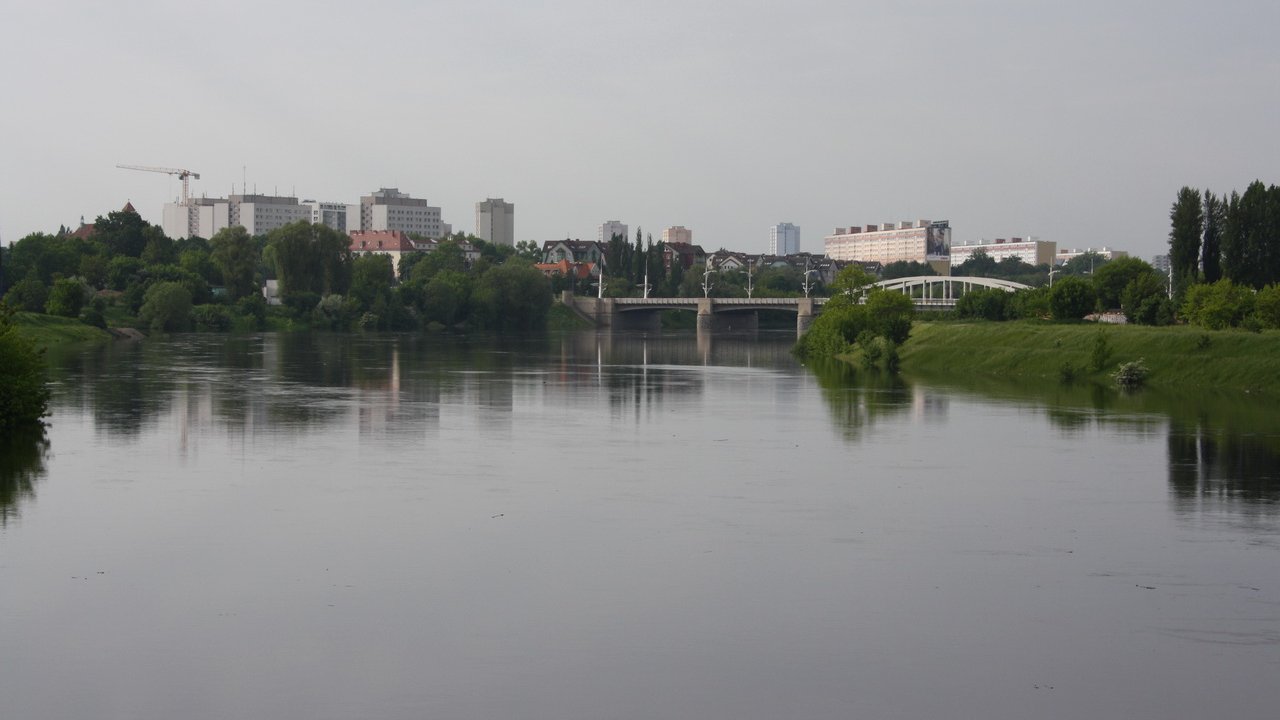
823, 220, 951, 274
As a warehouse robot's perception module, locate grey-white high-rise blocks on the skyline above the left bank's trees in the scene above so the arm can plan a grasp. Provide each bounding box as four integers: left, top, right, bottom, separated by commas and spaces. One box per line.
161, 187, 516, 246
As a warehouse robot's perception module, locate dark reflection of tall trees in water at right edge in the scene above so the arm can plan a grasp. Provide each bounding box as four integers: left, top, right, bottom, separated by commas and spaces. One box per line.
1169, 421, 1280, 512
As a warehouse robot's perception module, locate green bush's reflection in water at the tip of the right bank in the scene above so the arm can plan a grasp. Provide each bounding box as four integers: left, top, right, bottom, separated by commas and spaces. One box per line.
808, 360, 911, 441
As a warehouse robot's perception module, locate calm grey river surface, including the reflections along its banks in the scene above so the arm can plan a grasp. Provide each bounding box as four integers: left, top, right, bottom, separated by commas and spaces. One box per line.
0, 333, 1280, 720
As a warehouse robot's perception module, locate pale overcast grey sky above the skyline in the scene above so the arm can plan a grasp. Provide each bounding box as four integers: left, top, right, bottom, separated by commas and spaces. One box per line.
0, 0, 1280, 258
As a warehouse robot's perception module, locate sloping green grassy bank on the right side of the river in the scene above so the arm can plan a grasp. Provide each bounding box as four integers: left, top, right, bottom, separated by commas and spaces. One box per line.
900, 322, 1280, 393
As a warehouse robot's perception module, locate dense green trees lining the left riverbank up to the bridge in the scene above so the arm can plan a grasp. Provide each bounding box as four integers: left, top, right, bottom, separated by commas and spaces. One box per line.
0, 209, 550, 331
